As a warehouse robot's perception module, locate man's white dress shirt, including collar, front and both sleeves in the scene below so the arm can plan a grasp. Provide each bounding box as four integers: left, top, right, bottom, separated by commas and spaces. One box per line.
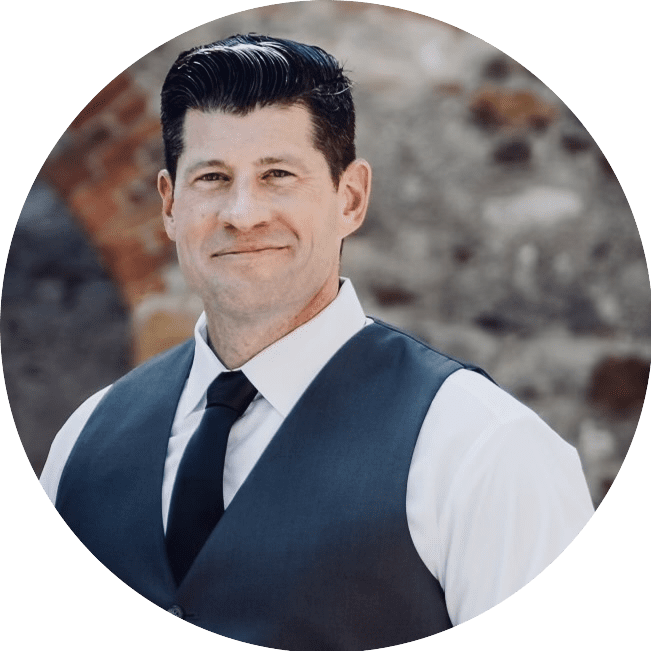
40, 280, 594, 626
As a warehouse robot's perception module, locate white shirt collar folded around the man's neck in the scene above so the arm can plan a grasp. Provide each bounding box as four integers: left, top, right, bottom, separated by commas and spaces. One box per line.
179, 278, 366, 418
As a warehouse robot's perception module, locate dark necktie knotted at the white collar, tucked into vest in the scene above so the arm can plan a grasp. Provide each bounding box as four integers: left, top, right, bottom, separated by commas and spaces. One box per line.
166, 371, 257, 583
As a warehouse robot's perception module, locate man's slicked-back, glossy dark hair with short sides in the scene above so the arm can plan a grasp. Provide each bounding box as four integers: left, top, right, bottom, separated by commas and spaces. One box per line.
161, 34, 355, 186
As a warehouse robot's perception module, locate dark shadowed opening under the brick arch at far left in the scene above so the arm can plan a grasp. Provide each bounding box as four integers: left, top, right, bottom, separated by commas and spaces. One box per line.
1, 183, 130, 473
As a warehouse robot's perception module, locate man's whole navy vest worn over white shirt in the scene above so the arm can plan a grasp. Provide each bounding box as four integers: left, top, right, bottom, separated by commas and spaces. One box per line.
56, 322, 488, 651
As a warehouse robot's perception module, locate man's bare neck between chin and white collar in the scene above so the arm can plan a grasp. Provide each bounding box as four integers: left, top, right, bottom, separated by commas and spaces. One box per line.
205, 279, 339, 369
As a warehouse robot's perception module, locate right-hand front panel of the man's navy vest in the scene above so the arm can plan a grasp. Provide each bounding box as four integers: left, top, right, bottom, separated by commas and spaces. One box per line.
176, 324, 460, 651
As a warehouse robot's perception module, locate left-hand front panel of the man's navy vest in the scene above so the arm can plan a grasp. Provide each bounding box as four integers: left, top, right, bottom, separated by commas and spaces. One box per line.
56, 341, 194, 605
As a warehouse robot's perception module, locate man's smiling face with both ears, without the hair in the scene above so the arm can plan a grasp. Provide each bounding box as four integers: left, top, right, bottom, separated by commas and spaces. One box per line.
159, 105, 370, 326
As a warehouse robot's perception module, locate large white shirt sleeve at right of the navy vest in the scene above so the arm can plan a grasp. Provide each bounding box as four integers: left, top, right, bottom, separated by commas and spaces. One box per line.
407, 371, 594, 626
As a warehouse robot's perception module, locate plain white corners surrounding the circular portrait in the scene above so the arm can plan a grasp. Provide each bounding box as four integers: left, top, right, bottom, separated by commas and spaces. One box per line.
0, 0, 651, 651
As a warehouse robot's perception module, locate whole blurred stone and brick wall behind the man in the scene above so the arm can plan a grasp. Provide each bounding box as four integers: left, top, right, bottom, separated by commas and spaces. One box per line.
1, 2, 651, 504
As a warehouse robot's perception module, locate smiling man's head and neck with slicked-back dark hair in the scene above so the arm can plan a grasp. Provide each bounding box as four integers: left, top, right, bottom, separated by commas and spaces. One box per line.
158, 36, 371, 356
